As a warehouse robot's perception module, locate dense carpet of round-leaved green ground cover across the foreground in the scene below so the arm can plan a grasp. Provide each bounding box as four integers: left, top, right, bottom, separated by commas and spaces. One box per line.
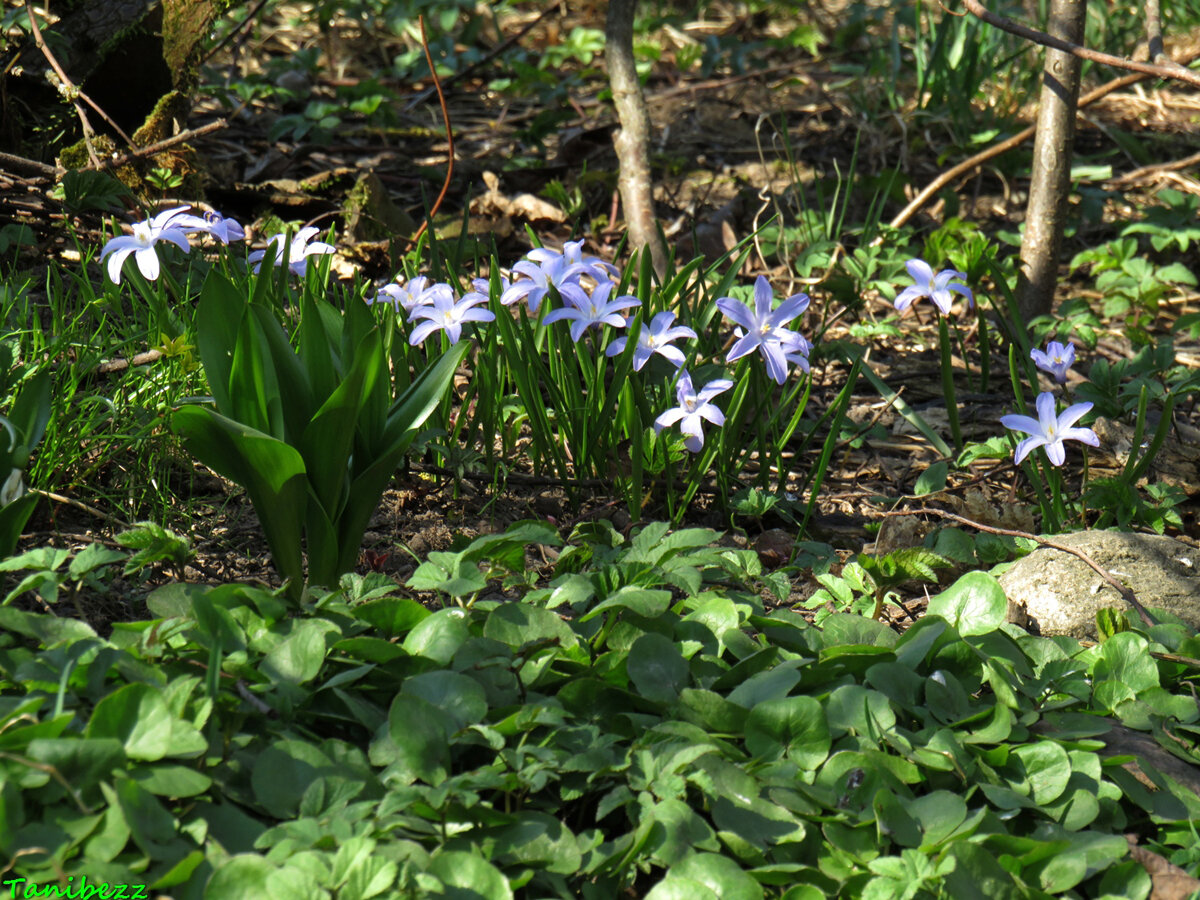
0, 522, 1200, 900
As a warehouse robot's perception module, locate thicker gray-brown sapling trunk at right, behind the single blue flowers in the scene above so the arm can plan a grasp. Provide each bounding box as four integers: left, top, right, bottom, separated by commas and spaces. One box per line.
1016, 0, 1087, 322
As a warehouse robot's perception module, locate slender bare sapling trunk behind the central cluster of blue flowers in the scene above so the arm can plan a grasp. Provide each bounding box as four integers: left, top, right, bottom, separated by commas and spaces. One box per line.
604, 0, 666, 277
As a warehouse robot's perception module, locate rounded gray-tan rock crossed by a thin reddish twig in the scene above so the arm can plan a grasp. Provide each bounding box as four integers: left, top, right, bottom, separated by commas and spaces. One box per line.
1000, 532, 1200, 638
